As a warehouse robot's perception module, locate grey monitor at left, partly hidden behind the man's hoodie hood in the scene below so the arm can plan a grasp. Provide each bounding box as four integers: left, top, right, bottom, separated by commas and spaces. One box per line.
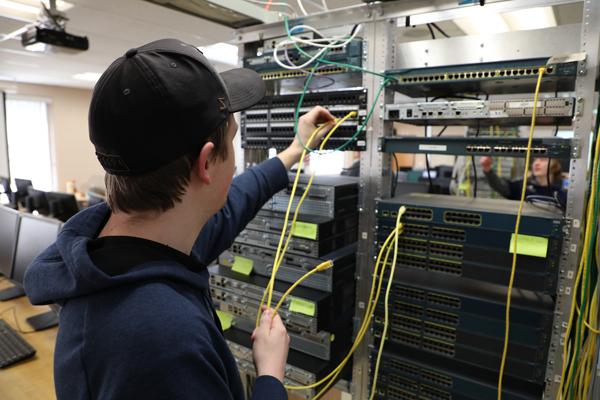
11, 214, 62, 284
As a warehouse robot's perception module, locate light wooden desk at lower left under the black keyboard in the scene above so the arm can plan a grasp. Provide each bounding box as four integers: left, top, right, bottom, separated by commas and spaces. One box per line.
0, 280, 58, 400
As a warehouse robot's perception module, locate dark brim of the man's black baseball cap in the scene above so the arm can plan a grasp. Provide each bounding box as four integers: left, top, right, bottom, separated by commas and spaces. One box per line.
219, 68, 266, 113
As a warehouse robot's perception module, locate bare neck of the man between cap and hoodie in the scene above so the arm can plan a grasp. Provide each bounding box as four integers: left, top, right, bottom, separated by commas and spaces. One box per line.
98, 199, 212, 255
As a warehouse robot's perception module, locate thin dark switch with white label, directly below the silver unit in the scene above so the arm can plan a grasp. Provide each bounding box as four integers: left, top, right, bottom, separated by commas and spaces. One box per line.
379, 136, 573, 159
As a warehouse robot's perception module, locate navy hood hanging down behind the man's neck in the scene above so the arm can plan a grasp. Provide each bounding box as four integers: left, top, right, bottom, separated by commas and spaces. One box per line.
23, 203, 208, 304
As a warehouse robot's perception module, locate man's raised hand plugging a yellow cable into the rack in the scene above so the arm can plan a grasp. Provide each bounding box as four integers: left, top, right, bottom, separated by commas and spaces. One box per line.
277, 106, 335, 169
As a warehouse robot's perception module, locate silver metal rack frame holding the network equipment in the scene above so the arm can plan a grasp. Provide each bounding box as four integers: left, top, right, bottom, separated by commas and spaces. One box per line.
235, 0, 600, 399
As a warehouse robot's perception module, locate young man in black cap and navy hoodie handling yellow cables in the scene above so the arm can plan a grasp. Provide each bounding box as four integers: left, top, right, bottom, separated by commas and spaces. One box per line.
25, 39, 333, 399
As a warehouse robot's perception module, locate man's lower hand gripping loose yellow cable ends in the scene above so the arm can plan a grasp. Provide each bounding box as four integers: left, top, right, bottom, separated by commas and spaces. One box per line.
252, 308, 290, 383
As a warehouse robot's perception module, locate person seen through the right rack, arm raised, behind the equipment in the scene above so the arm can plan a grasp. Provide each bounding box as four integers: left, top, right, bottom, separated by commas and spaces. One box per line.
479, 157, 567, 208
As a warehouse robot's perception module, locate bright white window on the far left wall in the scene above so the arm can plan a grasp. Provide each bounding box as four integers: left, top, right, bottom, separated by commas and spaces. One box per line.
6, 96, 54, 191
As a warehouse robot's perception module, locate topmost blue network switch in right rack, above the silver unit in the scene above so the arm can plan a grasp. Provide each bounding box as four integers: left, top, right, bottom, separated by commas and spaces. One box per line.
386, 58, 577, 97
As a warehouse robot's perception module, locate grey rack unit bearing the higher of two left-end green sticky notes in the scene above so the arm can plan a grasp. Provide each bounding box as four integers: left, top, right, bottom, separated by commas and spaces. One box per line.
219, 243, 356, 293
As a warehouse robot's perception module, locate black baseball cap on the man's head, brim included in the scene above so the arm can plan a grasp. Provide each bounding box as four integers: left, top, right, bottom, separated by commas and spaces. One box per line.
89, 39, 265, 175
